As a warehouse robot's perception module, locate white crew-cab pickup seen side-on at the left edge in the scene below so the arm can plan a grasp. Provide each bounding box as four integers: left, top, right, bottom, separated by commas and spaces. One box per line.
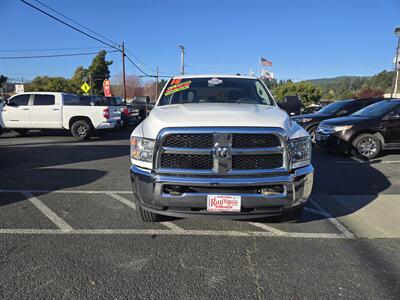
0, 92, 121, 140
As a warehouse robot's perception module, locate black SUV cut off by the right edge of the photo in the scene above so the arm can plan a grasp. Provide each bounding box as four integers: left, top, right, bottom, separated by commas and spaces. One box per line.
315, 99, 400, 159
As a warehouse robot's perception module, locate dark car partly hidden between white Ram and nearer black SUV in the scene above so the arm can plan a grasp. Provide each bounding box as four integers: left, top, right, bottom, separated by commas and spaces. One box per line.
292, 98, 383, 143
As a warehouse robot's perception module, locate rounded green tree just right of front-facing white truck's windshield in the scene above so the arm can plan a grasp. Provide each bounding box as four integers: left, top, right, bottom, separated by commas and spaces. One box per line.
272, 81, 322, 106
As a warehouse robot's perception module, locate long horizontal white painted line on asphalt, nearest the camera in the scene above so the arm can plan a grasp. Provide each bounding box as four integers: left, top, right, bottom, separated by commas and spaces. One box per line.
0, 229, 350, 239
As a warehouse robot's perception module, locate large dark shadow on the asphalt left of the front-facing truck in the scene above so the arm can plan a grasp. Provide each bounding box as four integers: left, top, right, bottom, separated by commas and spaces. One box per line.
0, 132, 129, 206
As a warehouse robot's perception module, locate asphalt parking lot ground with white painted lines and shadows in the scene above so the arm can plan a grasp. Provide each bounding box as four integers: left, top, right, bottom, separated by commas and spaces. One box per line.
0, 132, 400, 299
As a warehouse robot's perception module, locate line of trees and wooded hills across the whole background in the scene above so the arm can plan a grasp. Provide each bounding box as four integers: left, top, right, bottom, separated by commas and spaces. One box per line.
0, 50, 394, 106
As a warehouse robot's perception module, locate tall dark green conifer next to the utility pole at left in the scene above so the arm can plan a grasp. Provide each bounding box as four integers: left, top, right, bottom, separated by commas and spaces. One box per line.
88, 50, 113, 95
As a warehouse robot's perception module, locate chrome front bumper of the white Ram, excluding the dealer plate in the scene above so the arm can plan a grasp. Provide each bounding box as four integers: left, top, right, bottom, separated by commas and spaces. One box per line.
131, 165, 314, 219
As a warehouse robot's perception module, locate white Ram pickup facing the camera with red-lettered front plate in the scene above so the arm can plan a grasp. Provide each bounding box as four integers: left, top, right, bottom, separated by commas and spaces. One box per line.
130, 75, 314, 222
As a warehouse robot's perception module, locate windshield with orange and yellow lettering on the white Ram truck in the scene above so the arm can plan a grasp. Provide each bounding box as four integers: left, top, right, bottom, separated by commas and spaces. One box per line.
158, 77, 274, 105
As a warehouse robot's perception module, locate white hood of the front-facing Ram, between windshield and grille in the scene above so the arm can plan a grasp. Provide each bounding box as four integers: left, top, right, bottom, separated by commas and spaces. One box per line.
139, 103, 307, 139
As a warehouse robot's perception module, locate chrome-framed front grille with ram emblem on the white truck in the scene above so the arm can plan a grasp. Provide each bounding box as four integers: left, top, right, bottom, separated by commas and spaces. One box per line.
154, 127, 288, 175
